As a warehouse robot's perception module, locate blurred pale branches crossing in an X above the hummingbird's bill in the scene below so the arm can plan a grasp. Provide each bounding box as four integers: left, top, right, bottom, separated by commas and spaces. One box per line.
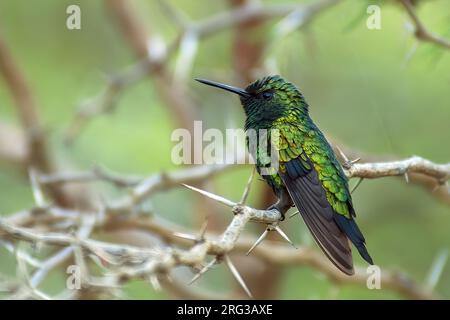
65, 0, 340, 144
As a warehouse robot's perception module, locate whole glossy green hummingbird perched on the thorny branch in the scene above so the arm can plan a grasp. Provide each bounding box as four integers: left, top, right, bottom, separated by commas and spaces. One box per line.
196, 75, 373, 275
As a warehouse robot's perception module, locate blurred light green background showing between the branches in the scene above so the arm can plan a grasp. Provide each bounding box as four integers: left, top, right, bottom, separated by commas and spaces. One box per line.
0, 0, 450, 299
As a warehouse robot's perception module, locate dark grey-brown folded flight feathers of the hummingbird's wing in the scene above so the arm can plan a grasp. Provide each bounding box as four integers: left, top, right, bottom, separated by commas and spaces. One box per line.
280, 158, 354, 275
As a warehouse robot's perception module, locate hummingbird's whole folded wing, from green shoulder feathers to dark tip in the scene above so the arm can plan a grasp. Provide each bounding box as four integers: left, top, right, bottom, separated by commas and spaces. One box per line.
272, 126, 354, 275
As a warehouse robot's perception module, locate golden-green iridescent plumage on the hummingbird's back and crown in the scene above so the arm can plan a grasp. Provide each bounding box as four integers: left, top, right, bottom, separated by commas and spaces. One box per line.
245, 76, 353, 218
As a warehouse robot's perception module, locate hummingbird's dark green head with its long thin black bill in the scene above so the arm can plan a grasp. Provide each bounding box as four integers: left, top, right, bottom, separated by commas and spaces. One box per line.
196, 75, 308, 126
